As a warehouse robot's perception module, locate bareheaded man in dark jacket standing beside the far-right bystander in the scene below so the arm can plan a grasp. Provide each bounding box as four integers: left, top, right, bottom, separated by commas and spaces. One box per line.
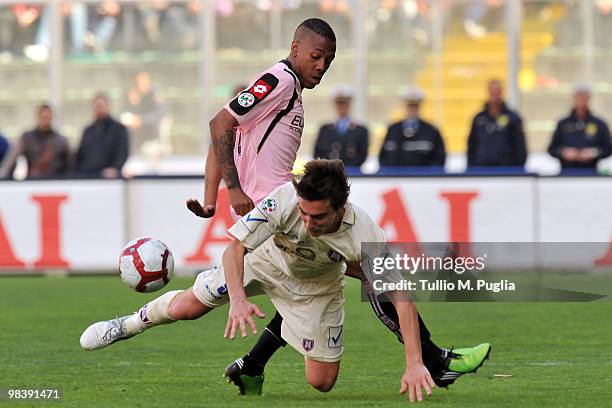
467, 79, 527, 168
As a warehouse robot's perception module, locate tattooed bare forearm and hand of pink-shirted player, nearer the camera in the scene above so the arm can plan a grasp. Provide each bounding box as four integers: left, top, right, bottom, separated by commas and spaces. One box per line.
210, 109, 255, 216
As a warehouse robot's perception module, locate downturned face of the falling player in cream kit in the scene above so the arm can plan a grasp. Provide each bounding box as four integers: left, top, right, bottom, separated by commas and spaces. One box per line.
298, 197, 344, 237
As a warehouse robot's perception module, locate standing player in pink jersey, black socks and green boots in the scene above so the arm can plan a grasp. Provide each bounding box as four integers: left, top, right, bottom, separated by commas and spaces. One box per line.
187, 18, 490, 394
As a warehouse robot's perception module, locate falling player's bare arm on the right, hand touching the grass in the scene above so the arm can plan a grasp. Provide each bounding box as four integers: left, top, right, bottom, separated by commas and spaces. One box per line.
387, 291, 436, 402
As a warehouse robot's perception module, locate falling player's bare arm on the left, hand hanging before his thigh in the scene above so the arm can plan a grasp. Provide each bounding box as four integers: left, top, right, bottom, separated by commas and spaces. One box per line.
222, 234, 266, 339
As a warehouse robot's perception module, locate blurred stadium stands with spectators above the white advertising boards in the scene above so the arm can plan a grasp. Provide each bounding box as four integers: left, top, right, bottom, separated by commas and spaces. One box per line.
0, 0, 612, 178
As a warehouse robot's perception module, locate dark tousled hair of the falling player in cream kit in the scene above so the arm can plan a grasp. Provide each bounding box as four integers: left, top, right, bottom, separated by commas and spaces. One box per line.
293, 160, 351, 210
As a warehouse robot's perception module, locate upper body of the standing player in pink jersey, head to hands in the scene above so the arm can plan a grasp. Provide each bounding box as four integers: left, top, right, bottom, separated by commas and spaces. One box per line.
188, 18, 336, 218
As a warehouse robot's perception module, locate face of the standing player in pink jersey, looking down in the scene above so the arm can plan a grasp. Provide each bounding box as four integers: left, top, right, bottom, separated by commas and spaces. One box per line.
291, 32, 336, 89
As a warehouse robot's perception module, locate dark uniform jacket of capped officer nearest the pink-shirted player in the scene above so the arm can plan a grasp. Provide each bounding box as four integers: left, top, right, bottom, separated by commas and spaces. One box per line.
314, 118, 369, 167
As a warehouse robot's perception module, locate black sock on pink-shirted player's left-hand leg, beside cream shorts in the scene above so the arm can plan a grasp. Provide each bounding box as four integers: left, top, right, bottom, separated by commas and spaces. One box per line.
242, 312, 287, 376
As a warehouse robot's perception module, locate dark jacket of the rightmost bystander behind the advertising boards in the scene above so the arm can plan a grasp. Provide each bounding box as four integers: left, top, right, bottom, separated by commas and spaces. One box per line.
548, 110, 612, 168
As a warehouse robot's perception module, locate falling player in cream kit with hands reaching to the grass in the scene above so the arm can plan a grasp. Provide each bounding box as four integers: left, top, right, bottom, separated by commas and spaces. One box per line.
80, 160, 442, 401
